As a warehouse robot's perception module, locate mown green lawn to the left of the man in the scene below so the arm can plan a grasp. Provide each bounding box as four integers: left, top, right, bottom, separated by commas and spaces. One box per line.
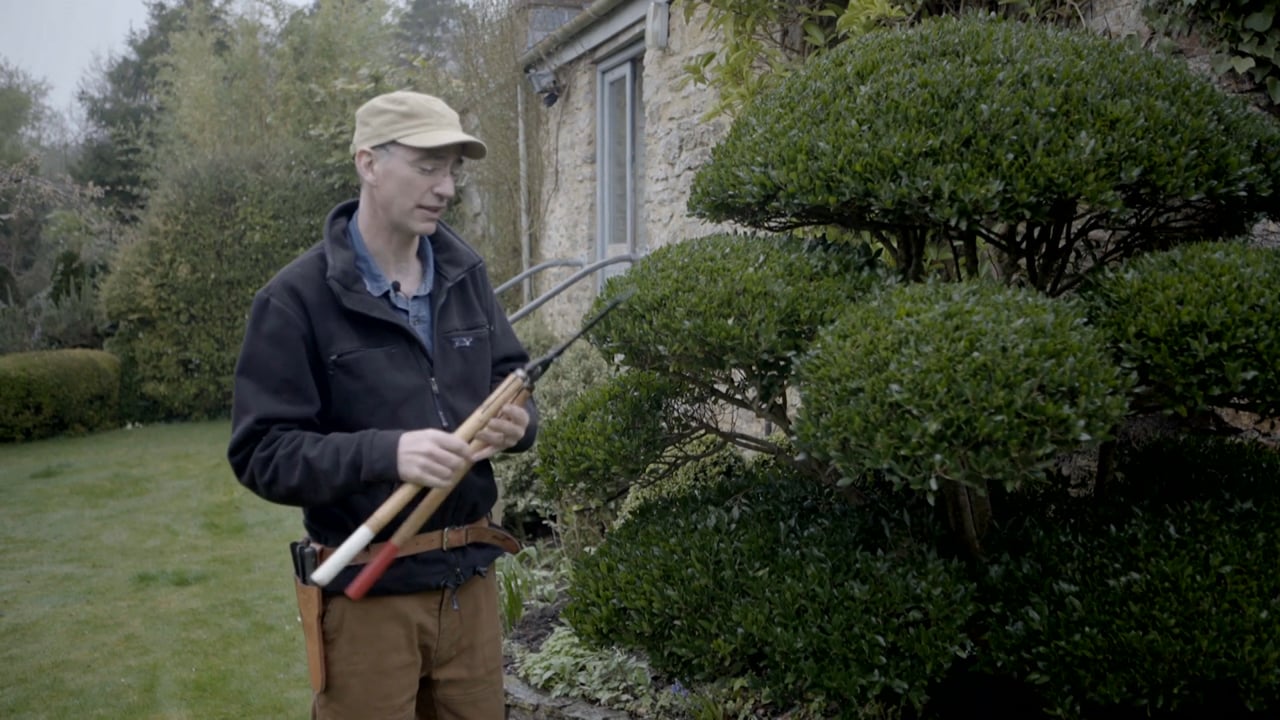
0, 420, 311, 720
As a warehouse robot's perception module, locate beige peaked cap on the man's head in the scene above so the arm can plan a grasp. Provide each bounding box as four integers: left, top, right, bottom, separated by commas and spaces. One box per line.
351, 90, 486, 160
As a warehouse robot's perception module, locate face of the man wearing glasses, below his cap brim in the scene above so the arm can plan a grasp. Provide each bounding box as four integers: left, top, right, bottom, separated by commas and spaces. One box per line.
371, 143, 462, 236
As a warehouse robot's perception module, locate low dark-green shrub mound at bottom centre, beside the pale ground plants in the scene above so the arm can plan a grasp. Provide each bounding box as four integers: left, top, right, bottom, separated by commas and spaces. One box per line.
563, 464, 975, 711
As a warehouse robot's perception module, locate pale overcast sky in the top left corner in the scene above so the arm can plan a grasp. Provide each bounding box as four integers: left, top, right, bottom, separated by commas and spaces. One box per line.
0, 0, 147, 113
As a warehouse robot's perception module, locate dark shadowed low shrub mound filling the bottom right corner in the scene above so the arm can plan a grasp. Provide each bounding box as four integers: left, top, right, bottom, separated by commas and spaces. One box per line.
978, 438, 1280, 717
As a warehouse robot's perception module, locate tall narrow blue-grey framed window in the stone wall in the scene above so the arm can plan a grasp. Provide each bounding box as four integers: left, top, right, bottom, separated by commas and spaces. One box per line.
595, 45, 644, 286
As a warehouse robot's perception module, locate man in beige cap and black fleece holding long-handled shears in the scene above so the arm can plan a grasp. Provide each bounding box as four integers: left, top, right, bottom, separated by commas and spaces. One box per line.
228, 91, 536, 720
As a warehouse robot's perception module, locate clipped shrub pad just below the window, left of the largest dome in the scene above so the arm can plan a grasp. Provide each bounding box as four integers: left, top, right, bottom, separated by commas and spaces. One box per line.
591, 234, 876, 420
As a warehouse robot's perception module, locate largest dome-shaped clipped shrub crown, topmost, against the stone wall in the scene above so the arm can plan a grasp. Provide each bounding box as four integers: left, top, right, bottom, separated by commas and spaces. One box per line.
689, 15, 1280, 295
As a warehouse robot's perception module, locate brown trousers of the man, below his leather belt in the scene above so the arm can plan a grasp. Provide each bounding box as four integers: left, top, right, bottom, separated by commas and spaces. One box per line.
311, 569, 507, 720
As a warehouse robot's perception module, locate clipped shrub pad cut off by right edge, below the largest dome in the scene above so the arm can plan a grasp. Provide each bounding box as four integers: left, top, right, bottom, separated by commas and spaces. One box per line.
1085, 242, 1280, 415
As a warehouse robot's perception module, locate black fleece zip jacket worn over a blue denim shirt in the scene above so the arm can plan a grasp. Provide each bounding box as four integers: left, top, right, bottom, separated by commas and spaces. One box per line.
228, 201, 538, 594
